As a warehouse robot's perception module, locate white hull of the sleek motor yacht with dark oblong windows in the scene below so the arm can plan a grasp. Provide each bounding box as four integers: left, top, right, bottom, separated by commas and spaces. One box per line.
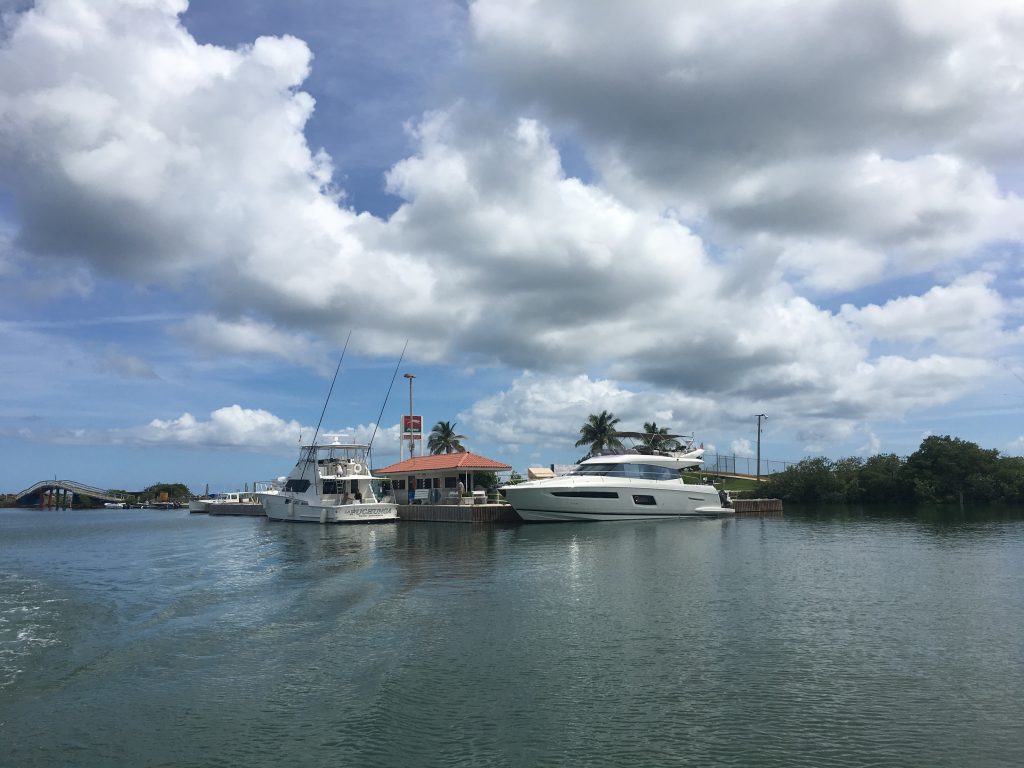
504, 478, 733, 522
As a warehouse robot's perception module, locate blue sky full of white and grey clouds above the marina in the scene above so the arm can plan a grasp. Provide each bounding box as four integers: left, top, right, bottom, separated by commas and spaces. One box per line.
0, 0, 1024, 493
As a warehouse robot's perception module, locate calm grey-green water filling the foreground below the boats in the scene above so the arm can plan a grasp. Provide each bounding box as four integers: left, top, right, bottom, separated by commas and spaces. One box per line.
0, 510, 1024, 768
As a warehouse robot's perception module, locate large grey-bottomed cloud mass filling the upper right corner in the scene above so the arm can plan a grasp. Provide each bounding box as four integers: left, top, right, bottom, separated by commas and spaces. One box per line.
472, 0, 1024, 292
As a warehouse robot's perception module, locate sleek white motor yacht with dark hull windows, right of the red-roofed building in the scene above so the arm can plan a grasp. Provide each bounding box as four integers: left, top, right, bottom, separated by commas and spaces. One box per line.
502, 438, 733, 522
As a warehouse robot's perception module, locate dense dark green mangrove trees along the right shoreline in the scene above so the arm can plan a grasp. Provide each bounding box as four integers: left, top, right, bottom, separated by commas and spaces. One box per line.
758, 435, 1024, 504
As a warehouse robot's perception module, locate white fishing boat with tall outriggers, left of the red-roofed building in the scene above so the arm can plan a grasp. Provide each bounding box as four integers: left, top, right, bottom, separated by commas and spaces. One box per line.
256, 437, 398, 522
